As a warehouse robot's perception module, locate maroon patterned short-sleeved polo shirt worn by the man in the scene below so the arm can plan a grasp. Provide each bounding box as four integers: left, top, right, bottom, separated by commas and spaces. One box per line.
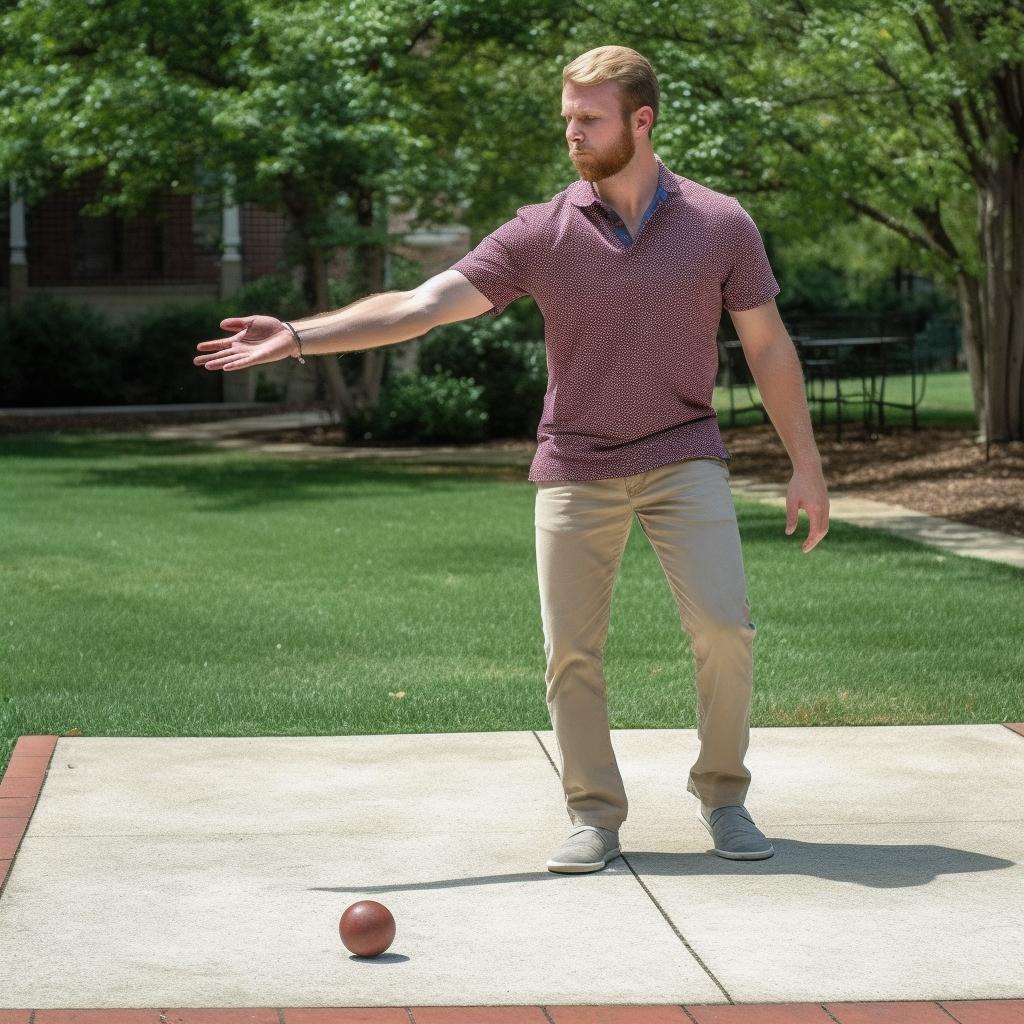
452, 159, 779, 482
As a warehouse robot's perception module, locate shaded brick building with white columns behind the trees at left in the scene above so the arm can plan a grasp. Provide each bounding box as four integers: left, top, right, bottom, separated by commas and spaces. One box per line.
0, 171, 471, 401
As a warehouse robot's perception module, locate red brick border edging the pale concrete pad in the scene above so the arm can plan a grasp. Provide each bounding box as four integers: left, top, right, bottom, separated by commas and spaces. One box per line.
0, 737, 1024, 1024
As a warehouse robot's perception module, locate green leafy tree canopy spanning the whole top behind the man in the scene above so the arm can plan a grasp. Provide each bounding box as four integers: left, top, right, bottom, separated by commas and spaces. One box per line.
0, 0, 1024, 434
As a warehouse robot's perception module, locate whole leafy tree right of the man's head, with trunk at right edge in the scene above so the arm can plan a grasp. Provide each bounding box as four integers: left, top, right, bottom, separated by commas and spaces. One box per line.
572, 0, 1024, 441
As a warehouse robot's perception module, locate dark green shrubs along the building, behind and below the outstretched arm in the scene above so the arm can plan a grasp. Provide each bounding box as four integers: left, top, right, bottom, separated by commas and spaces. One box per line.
0, 275, 547, 415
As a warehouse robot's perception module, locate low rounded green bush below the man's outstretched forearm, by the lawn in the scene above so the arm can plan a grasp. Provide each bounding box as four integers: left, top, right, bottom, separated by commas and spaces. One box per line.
344, 372, 487, 444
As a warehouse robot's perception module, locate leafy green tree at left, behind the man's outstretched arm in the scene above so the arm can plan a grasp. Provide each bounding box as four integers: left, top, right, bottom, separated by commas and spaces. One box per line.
0, 0, 561, 415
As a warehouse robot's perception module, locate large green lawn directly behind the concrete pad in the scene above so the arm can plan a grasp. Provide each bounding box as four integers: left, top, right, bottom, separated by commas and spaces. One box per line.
0, 415, 1024, 771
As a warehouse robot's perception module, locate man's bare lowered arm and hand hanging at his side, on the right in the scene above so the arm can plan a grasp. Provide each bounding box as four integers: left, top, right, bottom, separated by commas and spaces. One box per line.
729, 299, 829, 554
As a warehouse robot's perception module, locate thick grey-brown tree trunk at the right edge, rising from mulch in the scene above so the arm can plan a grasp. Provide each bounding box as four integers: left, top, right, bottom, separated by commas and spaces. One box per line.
978, 151, 1024, 442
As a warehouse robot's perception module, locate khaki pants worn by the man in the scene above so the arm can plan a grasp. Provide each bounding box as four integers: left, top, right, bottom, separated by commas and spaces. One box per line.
535, 458, 756, 830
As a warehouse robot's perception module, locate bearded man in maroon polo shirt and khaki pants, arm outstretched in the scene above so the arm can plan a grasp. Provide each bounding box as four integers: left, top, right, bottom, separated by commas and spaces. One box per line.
195, 46, 828, 873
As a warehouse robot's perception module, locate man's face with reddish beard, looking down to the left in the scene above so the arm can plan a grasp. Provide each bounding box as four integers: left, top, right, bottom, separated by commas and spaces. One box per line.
562, 82, 636, 181
